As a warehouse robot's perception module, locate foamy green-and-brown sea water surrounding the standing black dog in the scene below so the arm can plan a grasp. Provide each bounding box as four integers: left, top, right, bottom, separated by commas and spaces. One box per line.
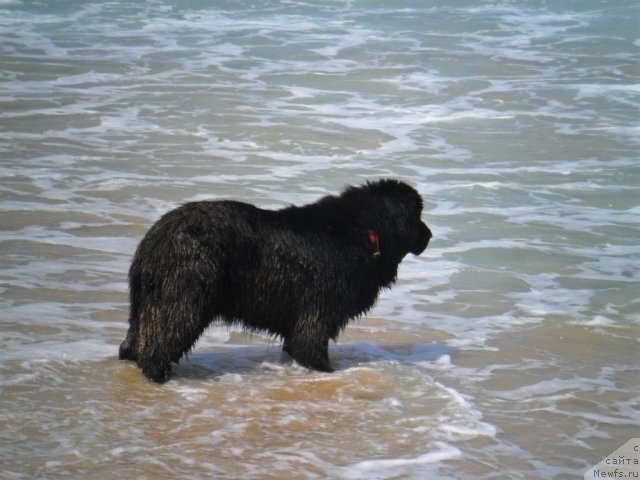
0, 0, 640, 479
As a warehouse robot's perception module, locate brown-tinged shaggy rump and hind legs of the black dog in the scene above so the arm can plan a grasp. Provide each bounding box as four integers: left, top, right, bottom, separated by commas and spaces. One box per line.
125, 224, 220, 383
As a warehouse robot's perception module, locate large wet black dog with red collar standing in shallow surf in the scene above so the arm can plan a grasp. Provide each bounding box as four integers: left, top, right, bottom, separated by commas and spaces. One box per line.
120, 180, 431, 382
